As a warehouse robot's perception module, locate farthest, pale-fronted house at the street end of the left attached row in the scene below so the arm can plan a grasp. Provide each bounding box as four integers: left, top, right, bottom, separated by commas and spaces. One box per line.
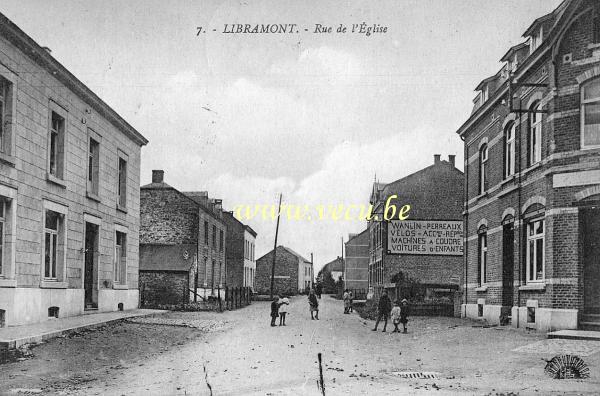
223, 212, 256, 289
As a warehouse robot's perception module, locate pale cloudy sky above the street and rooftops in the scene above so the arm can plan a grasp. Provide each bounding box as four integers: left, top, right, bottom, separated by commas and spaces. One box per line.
0, 0, 560, 270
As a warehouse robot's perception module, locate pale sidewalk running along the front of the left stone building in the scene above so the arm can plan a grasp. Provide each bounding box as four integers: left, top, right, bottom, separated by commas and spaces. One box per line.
0, 309, 168, 350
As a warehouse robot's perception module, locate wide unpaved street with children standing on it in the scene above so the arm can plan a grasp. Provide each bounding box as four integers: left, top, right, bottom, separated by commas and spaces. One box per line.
0, 296, 600, 395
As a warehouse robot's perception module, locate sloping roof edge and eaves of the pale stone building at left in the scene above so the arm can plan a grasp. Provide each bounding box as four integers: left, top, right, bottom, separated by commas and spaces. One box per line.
0, 13, 148, 146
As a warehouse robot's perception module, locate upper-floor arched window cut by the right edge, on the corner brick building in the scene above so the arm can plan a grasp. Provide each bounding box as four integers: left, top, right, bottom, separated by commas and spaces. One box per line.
581, 78, 600, 148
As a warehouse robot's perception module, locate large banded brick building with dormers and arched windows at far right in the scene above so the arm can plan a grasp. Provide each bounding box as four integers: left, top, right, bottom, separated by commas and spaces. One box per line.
457, 0, 600, 330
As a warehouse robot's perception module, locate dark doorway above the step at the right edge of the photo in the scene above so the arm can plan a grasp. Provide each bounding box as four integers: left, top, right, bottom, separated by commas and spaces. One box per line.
579, 206, 600, 315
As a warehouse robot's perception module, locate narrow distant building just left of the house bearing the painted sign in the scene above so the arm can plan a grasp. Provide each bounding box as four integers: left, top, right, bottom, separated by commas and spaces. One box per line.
344, 229, 369, 289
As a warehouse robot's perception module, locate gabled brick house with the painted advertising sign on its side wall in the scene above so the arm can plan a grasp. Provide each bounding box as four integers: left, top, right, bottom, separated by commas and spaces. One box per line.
368, 154, 464, 297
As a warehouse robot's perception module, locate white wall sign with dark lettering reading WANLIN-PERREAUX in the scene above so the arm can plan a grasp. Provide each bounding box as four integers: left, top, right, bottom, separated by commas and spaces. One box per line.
387, 220, 463, 256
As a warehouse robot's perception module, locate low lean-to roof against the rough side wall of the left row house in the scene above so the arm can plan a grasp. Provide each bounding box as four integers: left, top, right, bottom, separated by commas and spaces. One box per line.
140, 244, 197, 272
